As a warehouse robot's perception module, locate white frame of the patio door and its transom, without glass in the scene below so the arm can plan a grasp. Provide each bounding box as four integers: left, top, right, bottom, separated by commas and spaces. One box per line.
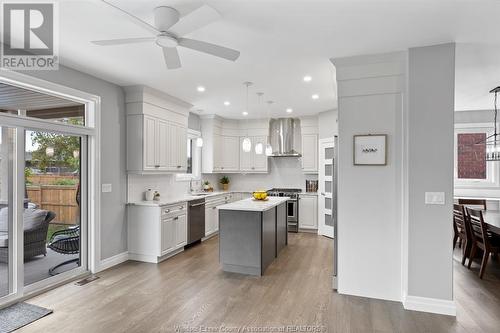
0, 70, 101, 307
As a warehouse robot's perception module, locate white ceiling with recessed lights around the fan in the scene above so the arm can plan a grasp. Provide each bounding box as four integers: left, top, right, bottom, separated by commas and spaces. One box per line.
56, 0, 500, 118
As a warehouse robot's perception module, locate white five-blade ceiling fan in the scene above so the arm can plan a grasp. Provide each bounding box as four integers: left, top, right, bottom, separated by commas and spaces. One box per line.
92, 0, 240, 69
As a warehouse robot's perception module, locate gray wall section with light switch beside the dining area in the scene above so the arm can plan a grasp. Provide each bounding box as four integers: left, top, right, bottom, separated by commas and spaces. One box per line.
408, 44, 455, 300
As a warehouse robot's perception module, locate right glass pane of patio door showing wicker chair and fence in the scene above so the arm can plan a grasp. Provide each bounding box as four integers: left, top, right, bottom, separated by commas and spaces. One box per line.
23, 130, 87, 289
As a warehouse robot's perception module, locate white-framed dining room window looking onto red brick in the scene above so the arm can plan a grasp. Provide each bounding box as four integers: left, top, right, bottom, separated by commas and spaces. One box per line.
455, 126, 498, 187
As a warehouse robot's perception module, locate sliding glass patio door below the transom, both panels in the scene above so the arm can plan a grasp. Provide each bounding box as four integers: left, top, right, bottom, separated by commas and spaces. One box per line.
0, 126, 88, 305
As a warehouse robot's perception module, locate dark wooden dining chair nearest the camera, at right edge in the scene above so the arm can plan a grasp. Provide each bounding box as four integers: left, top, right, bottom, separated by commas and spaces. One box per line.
467, 208, 500, 279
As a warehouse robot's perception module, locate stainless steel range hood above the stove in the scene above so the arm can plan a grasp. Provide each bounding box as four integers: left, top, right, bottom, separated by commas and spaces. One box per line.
269, 118, 302, 157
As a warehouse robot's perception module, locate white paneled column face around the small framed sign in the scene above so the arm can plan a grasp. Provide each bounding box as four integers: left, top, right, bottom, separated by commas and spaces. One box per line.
332, 52, 407, 301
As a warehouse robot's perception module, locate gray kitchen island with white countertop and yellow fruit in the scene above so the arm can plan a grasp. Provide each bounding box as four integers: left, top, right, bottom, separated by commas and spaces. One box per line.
218, 197, 288, 276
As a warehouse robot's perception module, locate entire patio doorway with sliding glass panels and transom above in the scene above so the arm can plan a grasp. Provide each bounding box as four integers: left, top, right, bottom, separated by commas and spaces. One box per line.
0, 76, 96, 306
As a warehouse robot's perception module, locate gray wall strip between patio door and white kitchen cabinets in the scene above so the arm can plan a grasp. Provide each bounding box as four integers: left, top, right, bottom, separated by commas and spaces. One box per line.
26, 66, 127, 259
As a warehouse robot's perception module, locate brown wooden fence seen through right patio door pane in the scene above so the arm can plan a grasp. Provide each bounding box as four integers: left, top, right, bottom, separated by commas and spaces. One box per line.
26, 183, 80, 224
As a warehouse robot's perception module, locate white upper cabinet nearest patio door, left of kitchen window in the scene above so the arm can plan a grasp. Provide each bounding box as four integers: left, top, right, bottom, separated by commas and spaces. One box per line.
125, 86, 191, 173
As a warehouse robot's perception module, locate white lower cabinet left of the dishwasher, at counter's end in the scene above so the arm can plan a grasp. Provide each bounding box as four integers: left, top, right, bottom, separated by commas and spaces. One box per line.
127, 202, 187, 263
